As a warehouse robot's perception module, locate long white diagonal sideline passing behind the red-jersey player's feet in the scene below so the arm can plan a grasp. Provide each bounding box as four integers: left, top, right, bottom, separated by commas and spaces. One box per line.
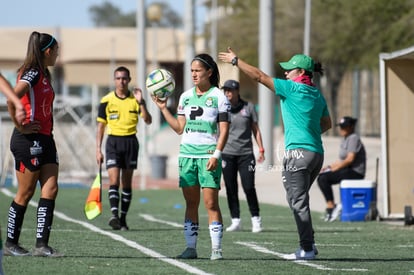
1, 188, 217, 275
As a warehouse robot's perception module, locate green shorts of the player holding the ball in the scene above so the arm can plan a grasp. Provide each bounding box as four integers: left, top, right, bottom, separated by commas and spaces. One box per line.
178, 157, 221, 189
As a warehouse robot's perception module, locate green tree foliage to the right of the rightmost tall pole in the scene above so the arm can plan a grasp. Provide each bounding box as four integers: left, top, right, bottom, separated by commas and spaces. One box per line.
311, 0, 414, 125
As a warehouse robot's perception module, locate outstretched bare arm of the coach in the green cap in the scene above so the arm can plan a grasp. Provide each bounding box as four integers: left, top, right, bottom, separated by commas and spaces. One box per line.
218, 47, 275, 91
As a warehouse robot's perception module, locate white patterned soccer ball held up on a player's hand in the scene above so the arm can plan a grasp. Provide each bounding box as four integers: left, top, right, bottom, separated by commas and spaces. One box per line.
145, 69, 175, 100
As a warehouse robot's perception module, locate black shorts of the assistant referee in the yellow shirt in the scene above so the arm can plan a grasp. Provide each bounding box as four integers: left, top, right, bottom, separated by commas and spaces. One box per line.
105, 135, 139, 169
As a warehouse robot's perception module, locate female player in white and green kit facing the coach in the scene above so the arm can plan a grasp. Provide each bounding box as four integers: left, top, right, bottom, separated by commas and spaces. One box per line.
153, 54, 230, 260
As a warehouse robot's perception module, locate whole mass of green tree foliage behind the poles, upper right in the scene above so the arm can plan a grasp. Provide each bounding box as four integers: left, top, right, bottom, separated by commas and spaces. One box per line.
213, 0, 414, 127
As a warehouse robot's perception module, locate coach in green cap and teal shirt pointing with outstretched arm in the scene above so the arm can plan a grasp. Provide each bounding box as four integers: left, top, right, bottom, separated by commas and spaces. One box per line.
219, 48, 332, 260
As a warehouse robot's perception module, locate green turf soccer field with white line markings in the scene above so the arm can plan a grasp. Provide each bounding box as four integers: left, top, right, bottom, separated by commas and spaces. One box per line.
0, 188, 414, 275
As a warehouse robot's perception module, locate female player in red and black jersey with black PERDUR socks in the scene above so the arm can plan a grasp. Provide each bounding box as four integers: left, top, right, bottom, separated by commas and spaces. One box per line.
4, 31, 62, 257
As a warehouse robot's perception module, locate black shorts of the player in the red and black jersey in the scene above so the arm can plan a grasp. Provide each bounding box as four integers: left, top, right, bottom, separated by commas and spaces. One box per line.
10, 128, 59, 173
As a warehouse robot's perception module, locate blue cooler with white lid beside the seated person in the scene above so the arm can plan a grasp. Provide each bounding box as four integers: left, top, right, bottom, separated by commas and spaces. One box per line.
340, 180, 377, 222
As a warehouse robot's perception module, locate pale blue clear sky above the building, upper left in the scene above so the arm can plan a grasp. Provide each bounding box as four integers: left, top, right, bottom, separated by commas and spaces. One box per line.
0, 0, 205, 30
